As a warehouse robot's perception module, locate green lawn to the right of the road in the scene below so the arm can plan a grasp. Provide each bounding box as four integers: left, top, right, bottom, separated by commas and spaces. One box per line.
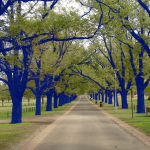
93, 98, 150, 136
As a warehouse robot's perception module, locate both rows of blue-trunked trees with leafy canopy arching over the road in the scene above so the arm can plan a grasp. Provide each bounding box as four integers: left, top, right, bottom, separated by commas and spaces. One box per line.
0, 0, 150, 123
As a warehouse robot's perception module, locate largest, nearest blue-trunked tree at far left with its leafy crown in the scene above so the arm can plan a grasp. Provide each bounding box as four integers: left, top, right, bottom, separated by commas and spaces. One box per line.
0, 2, 97, 123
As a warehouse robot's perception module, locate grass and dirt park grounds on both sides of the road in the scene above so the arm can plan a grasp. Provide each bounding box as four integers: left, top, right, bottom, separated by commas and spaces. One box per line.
0, 96, 150, 150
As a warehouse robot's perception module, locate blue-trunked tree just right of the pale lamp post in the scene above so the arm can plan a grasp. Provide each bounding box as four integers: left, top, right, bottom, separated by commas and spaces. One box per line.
89, 35, 131, 108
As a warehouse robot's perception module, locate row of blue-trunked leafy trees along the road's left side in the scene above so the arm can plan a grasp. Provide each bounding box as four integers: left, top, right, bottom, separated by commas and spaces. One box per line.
0, 1, 96, 123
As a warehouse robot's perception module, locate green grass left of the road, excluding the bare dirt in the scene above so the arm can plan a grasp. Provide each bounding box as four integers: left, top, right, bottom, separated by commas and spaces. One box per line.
0, 99, 78, 150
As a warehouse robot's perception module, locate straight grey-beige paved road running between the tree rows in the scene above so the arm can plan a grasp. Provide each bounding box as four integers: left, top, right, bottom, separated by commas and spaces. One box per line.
34, 96, 150, 150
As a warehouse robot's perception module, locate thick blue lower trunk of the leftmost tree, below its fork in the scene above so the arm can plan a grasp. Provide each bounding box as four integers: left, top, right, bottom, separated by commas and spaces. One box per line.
11, 99, 22, 124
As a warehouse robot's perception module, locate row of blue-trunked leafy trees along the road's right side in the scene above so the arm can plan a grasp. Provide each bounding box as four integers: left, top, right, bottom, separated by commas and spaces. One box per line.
71, 0, 150, 113
